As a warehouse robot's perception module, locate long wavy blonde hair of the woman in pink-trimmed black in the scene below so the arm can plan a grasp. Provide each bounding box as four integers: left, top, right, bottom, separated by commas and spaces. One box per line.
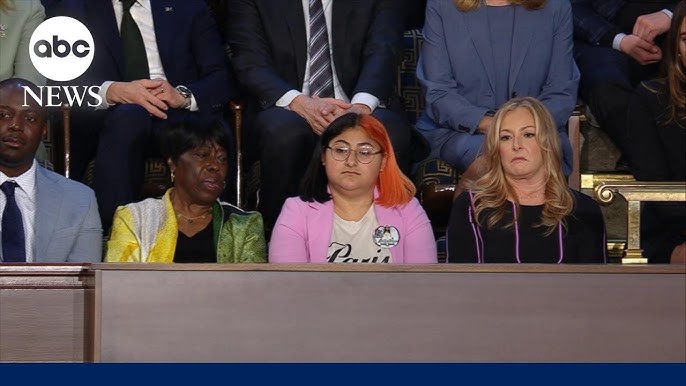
468, 97, 574, 235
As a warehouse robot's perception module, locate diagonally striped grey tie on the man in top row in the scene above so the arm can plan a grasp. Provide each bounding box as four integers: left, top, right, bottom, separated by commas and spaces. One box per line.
310, 0, 334, 98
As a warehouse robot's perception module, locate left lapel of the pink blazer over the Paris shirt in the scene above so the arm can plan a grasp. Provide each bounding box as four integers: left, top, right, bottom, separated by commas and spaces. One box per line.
306, 200, 333, 263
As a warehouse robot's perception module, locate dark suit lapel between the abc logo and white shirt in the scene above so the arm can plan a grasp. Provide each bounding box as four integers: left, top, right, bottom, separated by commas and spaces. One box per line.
85, 0, 124, 75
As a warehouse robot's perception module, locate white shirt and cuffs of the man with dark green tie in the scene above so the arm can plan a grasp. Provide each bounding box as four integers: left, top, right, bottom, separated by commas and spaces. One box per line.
98, 0, 198, 111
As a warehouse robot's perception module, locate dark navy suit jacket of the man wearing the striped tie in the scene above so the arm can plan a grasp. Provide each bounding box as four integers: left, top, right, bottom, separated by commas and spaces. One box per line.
228, 0, 403, 109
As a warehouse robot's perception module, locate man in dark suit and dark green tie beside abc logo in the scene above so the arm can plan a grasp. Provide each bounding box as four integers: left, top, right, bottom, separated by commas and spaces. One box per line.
46, 0, 236, 229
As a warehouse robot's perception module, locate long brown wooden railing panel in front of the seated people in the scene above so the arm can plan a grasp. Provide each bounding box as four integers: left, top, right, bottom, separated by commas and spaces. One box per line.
0, 263, 686, 363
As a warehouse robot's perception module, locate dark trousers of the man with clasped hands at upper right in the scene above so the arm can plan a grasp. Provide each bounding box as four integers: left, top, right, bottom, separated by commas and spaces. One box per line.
574, 42, 656, 160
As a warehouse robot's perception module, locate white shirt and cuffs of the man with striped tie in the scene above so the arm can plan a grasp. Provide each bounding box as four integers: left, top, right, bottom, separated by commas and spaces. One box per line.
276, 0, 381, 111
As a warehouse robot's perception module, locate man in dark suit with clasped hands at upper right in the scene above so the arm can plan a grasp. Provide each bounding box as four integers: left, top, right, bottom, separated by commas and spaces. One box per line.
572, 0, 677, 168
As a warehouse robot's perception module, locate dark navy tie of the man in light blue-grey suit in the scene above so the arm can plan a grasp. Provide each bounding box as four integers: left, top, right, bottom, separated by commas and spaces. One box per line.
0, 181, 26, 263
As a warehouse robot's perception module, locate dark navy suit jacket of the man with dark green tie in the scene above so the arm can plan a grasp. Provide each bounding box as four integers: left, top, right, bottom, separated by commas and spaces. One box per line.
44, 0, 237, 112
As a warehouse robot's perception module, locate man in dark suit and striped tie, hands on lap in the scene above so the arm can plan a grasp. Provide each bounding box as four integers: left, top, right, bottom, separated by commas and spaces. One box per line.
228, 0, 425, 232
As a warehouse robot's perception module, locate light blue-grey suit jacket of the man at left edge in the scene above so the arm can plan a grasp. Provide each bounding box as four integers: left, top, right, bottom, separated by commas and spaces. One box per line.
34, 167, 102, 263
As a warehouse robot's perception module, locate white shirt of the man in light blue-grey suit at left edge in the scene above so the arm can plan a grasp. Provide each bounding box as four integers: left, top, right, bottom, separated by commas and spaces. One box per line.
0, 160, 37, 263
